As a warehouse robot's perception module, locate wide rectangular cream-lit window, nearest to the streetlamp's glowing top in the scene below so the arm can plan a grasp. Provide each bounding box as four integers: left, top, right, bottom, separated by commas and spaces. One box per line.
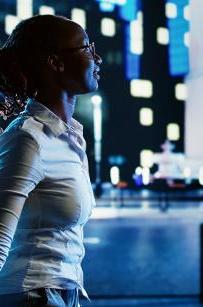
130, 79, 153, 98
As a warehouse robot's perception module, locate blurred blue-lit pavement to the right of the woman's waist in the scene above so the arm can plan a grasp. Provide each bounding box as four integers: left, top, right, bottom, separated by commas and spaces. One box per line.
81, 192, 203, 307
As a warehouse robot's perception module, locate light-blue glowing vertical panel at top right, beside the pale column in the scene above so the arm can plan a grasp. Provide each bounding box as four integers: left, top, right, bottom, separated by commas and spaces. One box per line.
166, 0, 189, 76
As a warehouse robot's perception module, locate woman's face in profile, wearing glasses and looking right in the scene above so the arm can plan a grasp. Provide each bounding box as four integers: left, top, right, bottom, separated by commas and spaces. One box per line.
58, 22, 102, 95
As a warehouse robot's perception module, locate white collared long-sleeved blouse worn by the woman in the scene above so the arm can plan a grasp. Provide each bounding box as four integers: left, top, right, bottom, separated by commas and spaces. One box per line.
0, 99, 95, 298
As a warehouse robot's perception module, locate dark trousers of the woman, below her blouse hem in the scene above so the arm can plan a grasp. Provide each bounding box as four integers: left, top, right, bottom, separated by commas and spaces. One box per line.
0, 288, 80, 307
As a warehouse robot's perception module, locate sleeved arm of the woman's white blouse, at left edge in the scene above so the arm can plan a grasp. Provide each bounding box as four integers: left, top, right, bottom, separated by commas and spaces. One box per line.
0, 129, 44, 270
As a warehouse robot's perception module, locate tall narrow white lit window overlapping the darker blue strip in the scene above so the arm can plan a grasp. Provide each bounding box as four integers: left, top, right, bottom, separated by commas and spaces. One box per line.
130, 12, 144, 55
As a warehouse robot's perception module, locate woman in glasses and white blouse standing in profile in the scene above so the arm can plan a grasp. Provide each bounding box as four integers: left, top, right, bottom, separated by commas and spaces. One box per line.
0, 15, 102, 307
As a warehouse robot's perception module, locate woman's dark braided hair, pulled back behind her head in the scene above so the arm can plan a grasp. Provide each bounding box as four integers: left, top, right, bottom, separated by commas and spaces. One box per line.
0, 15, 67, 124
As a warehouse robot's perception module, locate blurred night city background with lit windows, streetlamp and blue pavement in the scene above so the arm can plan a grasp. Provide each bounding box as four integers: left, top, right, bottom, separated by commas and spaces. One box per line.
0, 0, 203, 307
